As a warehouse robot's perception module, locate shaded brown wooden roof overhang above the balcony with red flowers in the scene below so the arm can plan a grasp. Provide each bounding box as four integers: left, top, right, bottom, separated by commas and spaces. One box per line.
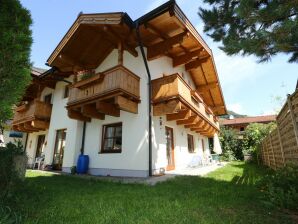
47, 12, 137, 72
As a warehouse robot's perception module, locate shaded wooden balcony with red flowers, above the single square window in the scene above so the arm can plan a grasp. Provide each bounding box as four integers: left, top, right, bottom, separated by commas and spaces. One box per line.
67, 65, 140, 121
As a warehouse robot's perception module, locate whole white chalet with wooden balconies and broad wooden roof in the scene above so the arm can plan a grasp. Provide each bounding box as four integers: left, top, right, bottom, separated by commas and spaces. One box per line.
12, 1, 226, 177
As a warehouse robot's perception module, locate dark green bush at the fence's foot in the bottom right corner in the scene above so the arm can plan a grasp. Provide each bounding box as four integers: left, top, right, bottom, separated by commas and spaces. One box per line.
258, 165, 298, 210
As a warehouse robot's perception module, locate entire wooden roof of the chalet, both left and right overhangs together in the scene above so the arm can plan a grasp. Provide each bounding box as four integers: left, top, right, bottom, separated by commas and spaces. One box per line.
47, 0, 227, 115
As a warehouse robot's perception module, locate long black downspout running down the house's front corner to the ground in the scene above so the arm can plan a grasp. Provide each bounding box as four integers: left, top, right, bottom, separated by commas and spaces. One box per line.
136, 22, 152, 176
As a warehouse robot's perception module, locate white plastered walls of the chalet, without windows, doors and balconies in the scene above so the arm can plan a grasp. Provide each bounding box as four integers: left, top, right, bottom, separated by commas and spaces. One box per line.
27, 49, 210, 177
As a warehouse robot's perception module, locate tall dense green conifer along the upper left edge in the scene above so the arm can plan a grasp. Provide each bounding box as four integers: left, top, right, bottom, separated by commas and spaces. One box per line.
0, 0, 32, 133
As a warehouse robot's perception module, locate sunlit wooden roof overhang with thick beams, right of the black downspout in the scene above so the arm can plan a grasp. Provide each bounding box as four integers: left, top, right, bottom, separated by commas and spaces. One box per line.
135, 1, 227, 115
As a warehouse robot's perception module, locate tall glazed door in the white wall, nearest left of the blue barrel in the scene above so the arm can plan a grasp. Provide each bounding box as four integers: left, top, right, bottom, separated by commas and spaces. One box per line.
53, 129, 66, 170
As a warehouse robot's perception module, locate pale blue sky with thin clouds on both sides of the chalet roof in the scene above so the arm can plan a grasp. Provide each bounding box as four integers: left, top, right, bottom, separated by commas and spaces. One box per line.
21, 0, 298, 115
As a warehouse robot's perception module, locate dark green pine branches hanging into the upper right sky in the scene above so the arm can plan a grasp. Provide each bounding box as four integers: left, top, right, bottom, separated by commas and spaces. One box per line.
199, 0, 298, 62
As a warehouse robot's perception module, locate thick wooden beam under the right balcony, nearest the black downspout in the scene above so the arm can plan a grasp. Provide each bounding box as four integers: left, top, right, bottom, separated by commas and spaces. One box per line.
153, 99, 182, 116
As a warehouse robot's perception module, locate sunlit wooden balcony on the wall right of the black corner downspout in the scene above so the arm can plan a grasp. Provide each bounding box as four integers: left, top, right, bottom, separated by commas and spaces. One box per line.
152, 74, 219, 137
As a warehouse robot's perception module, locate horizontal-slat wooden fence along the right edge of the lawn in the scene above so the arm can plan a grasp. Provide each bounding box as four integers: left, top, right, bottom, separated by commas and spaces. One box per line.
261, 90, 298, 169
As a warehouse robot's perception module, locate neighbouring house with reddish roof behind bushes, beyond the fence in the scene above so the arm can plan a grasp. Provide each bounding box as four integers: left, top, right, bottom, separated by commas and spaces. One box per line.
220, 115, 276, 132
